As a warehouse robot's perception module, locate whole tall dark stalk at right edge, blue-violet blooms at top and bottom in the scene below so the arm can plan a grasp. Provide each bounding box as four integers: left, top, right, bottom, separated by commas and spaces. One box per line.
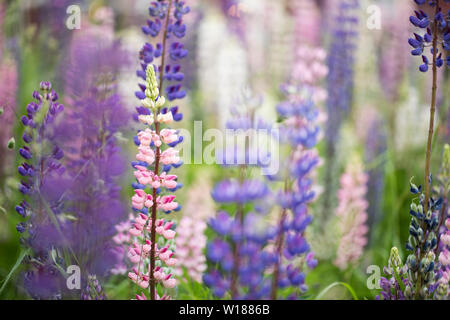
408, 0, 450, 299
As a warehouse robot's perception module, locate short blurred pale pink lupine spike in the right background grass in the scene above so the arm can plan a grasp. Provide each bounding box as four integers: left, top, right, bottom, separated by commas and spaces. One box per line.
334, 158, 368, 270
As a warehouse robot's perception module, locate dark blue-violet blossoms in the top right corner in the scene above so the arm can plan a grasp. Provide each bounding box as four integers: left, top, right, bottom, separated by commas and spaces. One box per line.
408, 0, 450, 72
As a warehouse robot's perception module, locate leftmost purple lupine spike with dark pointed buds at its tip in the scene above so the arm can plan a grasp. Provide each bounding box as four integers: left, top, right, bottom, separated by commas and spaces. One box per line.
16, 82, 68, 299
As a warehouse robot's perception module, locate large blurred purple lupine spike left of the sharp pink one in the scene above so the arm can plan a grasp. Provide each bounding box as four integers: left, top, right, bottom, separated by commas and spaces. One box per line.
59, 28, 131, 292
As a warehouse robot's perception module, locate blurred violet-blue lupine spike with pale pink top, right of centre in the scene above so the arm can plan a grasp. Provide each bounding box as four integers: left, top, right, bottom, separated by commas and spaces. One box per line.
271, 86, 319, 299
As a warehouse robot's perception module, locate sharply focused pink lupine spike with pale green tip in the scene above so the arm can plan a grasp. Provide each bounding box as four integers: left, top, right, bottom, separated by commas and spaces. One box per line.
126, 64, 180, 299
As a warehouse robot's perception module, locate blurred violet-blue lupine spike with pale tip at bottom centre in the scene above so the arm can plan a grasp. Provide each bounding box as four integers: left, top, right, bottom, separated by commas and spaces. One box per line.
203, 97, 275, 299
